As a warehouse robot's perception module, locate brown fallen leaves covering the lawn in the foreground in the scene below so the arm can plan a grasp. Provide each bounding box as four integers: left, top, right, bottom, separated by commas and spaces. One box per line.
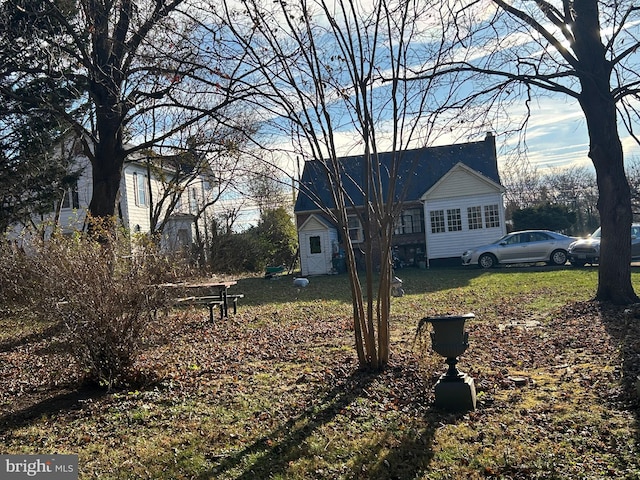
0, 302, 640, 478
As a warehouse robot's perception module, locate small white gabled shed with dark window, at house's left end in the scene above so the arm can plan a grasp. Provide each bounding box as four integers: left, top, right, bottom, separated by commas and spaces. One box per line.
298, 214, 338, 276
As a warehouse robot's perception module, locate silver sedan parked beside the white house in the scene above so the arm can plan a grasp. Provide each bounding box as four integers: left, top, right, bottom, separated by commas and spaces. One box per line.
462, 230, 576, 268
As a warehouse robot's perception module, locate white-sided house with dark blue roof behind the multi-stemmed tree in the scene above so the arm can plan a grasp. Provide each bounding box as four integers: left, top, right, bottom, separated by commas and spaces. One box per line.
294, 134, 506, 275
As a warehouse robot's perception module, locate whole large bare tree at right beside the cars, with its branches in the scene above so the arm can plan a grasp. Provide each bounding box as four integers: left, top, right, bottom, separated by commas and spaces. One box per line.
436, 0, 640, 304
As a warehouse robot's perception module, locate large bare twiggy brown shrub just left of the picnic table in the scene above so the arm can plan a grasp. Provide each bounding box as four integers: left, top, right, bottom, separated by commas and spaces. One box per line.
0, 226, 172, 388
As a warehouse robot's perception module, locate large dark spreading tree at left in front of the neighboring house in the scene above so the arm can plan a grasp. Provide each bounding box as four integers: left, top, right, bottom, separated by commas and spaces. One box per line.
0, 0, 250, 232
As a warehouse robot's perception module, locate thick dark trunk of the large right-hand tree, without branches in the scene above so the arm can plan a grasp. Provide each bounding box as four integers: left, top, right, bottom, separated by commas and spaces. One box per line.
573, 0, 638, 304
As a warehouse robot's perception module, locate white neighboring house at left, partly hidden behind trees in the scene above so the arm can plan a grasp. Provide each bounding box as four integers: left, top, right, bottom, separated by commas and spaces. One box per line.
10, 145, 211, 251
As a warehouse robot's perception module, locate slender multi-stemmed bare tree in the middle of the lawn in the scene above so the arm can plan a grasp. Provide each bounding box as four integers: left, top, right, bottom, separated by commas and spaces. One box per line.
224, 0, 452, 370
